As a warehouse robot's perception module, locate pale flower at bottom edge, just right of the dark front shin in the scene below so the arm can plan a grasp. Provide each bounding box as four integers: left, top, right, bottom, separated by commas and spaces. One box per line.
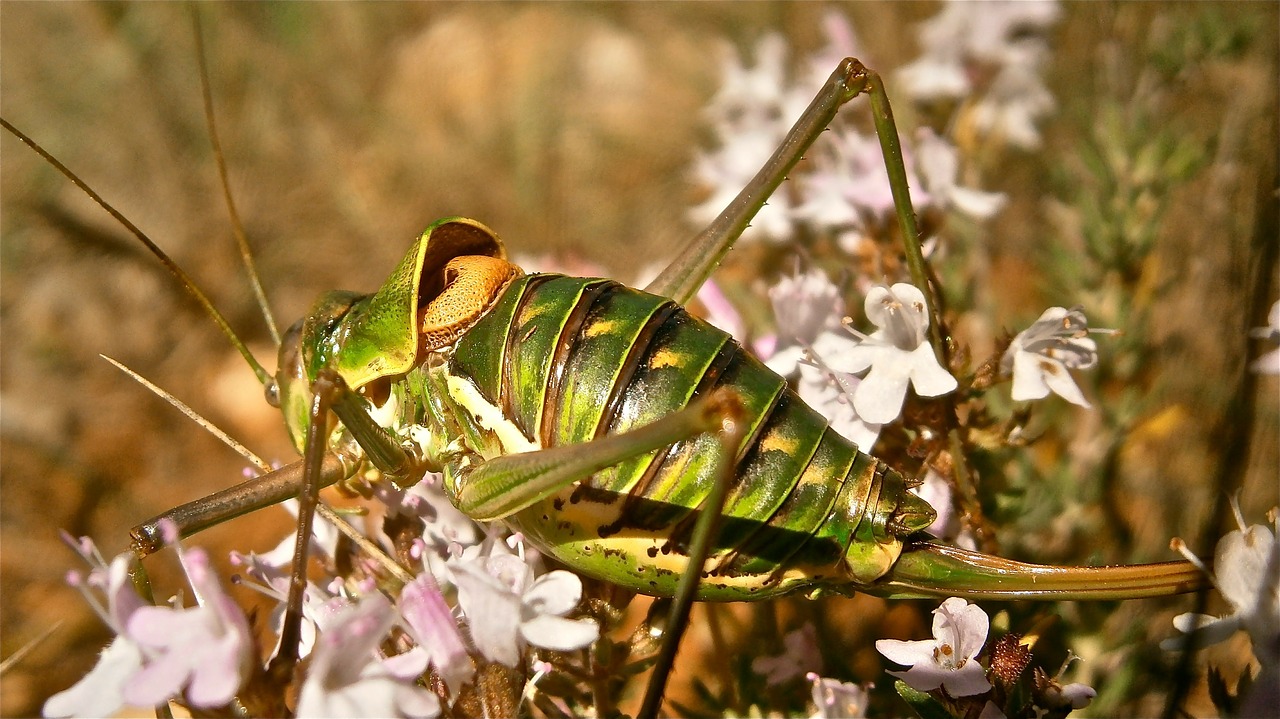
297, 592, 440, 718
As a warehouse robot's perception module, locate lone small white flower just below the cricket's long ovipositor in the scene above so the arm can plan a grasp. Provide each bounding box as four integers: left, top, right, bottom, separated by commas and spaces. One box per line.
876, 596, 991, 696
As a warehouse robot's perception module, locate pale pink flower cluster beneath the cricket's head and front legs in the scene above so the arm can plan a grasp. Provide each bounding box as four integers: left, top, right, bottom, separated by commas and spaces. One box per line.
45, 477, 599, 716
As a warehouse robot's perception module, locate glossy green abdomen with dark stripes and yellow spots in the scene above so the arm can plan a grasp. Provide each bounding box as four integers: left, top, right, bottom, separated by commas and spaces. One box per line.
449, 275, 926, 599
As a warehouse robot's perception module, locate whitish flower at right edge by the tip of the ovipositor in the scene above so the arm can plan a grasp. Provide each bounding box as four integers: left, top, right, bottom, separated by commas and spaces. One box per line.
1161, 498, 1280, 669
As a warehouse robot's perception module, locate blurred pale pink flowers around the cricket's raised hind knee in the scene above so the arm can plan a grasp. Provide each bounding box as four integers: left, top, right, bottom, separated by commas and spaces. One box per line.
690, 7, 1004, 252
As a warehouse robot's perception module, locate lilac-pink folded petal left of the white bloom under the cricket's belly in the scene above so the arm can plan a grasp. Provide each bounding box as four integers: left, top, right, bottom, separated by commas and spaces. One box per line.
452, 562, 520, 667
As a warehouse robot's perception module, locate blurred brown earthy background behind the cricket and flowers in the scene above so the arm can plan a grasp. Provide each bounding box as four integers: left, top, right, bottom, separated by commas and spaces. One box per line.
0, 3, 1280, 715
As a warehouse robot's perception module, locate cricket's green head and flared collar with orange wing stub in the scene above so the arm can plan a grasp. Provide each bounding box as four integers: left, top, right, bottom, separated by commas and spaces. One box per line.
268, 217, 520, 452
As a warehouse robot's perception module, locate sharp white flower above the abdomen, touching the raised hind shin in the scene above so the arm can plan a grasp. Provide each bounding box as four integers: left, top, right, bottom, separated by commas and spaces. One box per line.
824, 283, 957, 425
